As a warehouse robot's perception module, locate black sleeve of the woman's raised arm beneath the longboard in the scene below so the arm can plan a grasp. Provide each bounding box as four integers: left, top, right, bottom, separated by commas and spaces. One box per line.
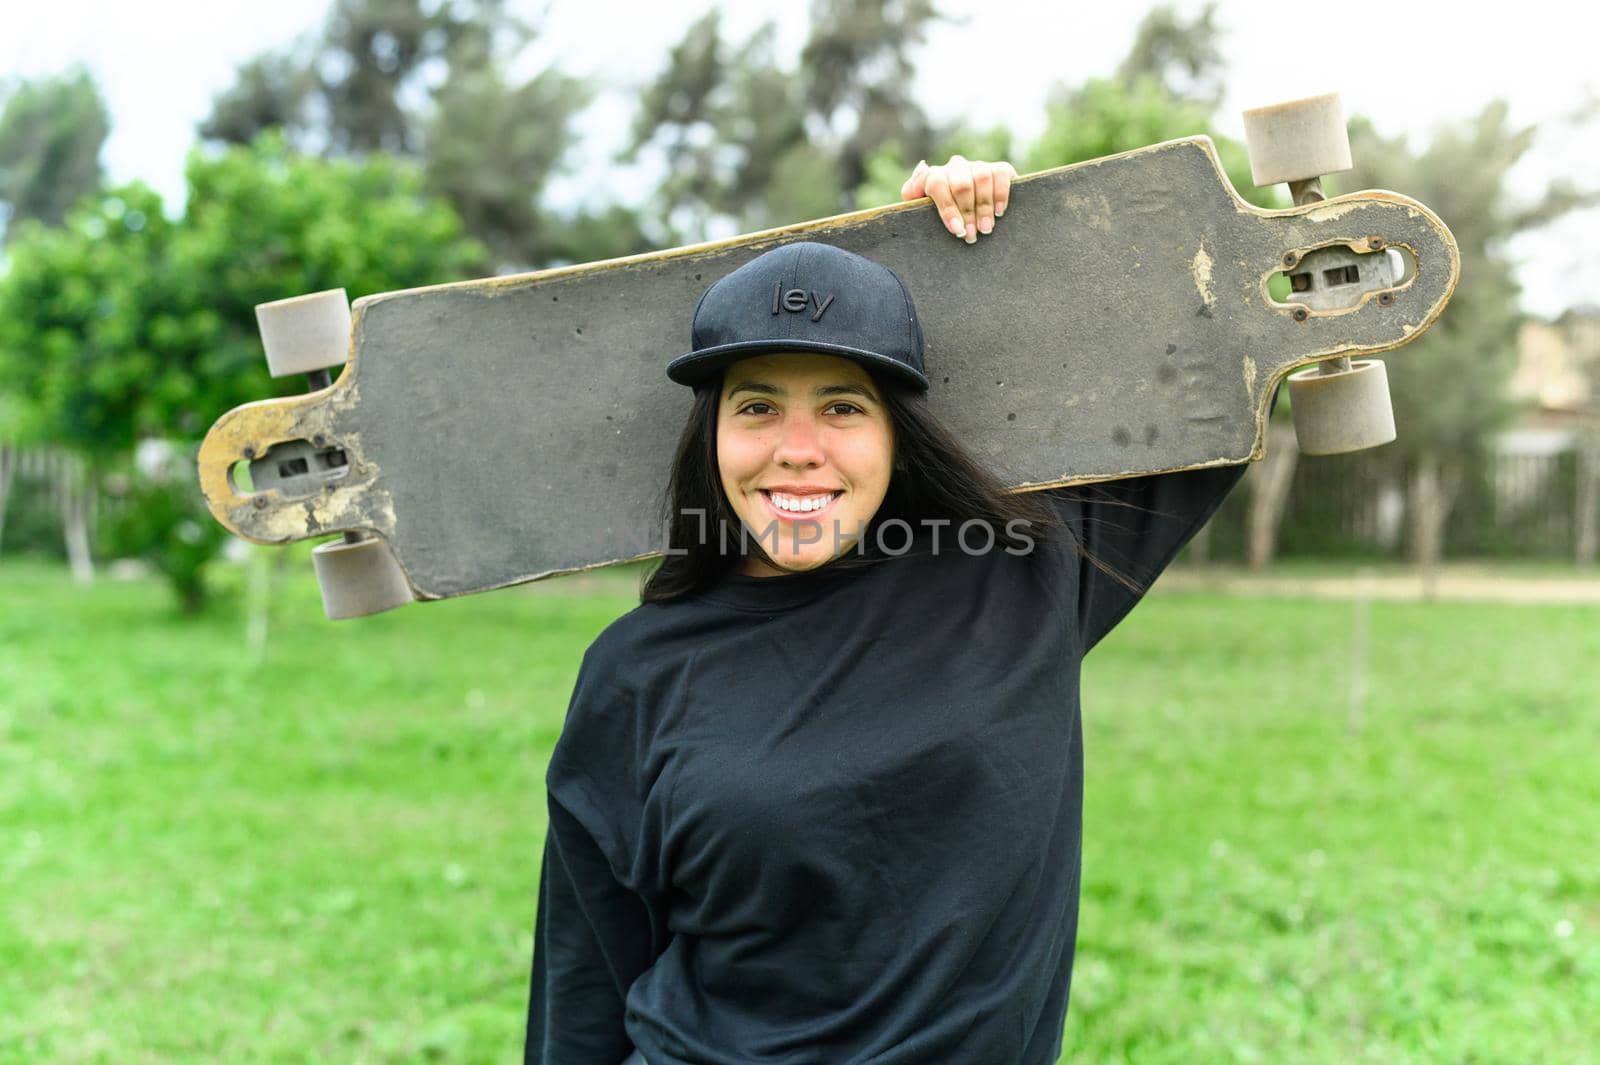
1046, 464, 1248, 654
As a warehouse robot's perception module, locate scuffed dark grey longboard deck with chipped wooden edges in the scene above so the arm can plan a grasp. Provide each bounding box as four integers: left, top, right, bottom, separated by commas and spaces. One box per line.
200, 138, 1459, 598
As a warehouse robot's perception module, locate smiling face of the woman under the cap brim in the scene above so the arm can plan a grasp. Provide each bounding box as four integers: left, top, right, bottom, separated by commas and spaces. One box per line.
717, 353, 894, 577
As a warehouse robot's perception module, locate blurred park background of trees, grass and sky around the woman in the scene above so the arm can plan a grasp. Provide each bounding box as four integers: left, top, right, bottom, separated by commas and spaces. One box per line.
0, 0, 1600, 1063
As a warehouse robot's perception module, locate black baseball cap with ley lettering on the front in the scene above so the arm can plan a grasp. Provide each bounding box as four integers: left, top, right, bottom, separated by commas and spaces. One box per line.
667, 241, 928, 390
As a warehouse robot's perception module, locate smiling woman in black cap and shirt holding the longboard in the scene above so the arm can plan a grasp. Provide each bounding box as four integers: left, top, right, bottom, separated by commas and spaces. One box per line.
525, 157, 1243, 1065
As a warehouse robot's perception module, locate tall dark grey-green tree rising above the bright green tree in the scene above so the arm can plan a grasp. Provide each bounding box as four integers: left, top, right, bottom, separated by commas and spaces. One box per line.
200, 0, 604, 269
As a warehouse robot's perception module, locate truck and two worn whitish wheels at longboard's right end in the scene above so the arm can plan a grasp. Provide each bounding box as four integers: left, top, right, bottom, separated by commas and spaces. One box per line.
1245, 93, 1405, 454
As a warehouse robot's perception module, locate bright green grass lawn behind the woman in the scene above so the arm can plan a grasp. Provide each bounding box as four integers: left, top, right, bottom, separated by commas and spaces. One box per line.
0, 560, 1600, 1065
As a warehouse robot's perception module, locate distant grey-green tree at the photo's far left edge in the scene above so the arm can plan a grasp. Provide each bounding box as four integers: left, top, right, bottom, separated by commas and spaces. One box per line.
0, 67, 110, 243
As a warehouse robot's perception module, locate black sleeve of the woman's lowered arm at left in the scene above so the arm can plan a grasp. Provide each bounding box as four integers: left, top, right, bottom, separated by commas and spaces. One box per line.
523, 642, 667, 1065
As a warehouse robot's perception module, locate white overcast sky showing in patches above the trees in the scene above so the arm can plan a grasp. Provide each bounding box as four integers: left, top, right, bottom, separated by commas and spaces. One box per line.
9, 0, 1600, 313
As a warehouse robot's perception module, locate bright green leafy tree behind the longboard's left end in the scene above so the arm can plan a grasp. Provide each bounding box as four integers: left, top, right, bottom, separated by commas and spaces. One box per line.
0, 134, 483, 609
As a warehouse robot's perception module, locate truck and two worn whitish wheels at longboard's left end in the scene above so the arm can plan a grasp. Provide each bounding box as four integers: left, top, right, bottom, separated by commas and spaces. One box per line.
251, 288, 413, 620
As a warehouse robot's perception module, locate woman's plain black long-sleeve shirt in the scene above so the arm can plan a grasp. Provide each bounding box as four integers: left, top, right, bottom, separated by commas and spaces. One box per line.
526, 467, 1245, 1065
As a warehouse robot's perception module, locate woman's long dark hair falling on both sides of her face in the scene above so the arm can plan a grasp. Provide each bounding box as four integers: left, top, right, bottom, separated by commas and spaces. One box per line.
640, 367, 1144, 603
